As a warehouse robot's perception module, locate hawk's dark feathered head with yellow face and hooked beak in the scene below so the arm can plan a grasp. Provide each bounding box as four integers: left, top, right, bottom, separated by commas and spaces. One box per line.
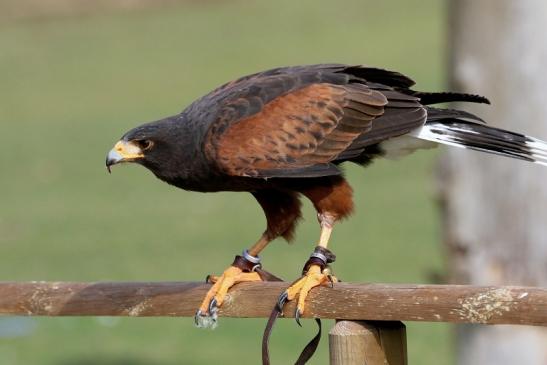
106, 117, 184, 176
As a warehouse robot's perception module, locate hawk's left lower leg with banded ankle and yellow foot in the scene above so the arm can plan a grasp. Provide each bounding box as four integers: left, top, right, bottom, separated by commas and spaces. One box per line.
195, 234, 271, 327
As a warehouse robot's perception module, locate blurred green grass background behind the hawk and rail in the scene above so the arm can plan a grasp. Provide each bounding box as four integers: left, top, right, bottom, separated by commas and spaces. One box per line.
0, 0, 452, 365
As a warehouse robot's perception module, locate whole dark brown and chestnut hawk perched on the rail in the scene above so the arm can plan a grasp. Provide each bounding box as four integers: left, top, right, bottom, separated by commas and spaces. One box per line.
106, 64, 547, 326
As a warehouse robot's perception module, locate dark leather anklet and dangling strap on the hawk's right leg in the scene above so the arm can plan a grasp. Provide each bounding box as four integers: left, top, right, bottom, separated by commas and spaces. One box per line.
262, 246, 336, 365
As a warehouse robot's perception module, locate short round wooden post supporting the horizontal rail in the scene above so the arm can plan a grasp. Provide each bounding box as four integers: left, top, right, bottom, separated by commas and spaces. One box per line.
329, 320, 407, 365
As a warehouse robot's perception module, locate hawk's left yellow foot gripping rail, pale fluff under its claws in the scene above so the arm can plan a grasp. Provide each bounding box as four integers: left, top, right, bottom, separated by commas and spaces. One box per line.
194, 266, 262, 328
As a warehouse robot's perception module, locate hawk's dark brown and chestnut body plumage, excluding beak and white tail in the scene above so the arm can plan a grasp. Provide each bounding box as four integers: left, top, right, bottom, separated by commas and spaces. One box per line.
106, 64, 485, 243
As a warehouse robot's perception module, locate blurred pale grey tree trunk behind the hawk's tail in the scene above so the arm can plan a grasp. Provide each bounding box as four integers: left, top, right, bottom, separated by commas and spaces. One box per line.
446, 0, 547, 365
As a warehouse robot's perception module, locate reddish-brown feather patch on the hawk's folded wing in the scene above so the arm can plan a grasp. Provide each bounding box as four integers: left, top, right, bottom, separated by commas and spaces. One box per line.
209, 83, 387, 177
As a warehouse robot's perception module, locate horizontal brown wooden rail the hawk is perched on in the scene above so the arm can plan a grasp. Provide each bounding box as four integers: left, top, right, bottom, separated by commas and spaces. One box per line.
0, 282, 547, 326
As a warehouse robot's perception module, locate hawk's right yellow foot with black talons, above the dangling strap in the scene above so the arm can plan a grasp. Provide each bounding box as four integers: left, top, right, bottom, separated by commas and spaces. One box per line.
277, 264, 338, 325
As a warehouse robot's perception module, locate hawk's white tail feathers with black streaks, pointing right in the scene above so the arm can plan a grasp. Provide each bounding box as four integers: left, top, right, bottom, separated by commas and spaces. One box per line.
410, 119, 547, 166
